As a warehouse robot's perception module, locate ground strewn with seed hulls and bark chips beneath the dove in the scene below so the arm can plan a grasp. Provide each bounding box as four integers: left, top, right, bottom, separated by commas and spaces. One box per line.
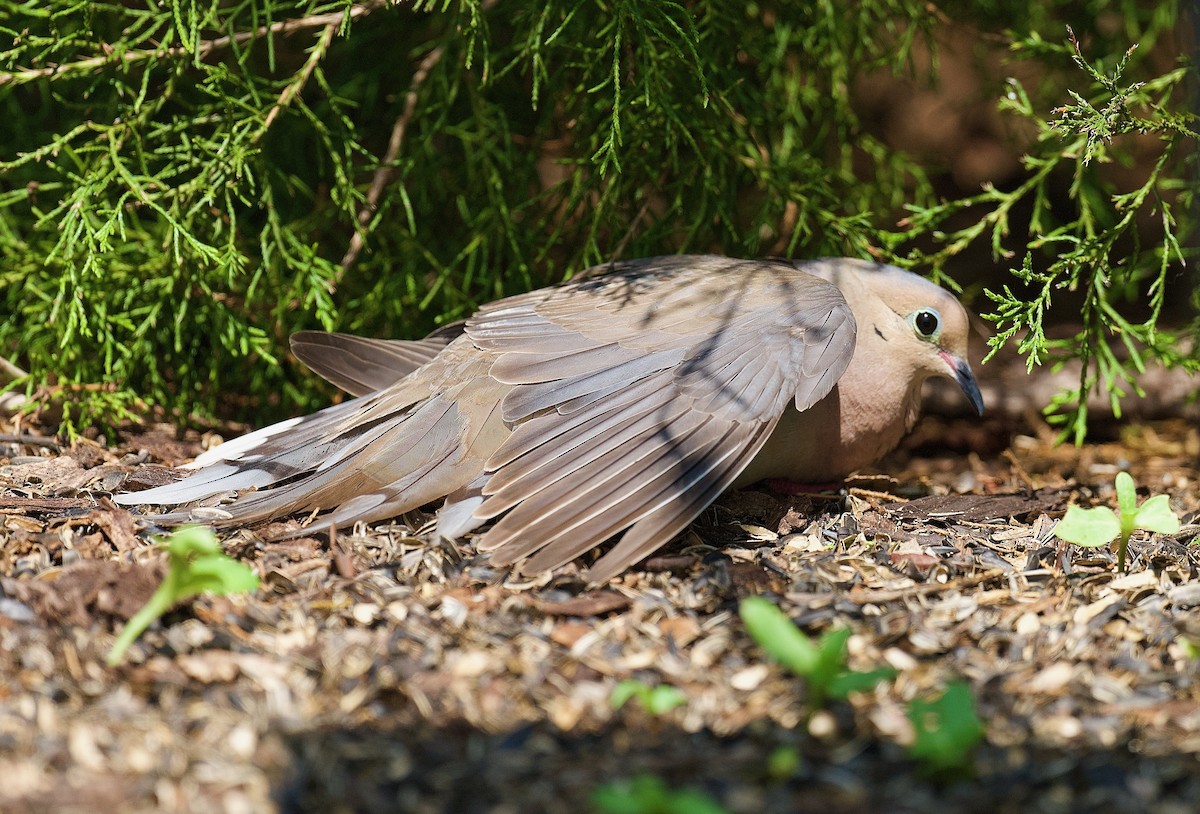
0, 408, 1200, 814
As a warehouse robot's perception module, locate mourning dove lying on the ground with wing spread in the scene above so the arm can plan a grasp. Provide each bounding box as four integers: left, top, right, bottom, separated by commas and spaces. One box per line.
116, 256, 983, 582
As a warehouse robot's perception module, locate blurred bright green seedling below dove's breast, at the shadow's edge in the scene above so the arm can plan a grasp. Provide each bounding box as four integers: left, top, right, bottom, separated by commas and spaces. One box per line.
740, 597, 895, 711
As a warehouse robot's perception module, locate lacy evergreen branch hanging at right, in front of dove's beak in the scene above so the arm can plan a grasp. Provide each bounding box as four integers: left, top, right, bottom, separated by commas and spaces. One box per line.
893, 29, 1200, 443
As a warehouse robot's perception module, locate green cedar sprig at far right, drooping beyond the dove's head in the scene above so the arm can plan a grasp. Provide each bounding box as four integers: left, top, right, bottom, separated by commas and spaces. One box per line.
889, 19, 1200, 443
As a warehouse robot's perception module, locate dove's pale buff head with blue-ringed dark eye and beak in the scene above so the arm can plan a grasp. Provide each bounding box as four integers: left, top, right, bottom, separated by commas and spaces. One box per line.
800, 259, 983, 415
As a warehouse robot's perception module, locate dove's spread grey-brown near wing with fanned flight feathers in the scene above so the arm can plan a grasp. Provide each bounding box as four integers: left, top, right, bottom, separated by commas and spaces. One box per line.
467, 257, 854, 582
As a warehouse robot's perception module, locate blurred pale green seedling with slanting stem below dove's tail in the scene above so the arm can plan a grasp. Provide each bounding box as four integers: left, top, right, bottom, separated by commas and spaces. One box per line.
108, 526, 258, 666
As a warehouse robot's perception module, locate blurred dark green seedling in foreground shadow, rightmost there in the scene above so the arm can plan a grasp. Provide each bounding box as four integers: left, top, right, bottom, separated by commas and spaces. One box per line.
908, 681, 984, 779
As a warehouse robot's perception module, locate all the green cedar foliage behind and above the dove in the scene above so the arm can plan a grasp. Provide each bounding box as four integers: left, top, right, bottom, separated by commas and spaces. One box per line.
0, 0, 1195, 439
